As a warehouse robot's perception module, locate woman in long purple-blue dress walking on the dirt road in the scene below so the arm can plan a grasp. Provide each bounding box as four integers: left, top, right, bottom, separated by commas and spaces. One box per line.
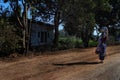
96, 27, 108, 63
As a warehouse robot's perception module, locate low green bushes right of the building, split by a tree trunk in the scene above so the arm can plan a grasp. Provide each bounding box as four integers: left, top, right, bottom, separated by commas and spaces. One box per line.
58, 37, 98, 50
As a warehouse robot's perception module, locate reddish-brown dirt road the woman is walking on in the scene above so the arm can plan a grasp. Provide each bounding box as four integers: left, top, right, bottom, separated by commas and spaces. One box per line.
0, 46, 120, 80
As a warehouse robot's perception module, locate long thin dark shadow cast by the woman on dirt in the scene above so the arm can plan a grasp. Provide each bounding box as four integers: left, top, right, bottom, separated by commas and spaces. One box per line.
52, 62, 101, 66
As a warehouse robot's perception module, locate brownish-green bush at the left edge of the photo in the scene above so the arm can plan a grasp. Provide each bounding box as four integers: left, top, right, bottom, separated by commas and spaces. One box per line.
0, 24, 21, 56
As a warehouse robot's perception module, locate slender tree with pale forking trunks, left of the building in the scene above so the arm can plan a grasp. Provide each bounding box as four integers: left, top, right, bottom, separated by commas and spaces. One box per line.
4, 0, 29, 53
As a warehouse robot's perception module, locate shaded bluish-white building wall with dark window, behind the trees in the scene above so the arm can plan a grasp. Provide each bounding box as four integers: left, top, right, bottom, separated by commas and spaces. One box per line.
31, 24, 54, 46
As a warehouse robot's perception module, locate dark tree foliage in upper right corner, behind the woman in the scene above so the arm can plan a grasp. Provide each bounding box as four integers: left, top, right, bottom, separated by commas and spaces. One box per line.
96, 0, 120, 40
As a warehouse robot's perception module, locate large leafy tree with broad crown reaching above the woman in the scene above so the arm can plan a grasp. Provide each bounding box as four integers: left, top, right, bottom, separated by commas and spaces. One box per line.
65, 0, 111, 47
